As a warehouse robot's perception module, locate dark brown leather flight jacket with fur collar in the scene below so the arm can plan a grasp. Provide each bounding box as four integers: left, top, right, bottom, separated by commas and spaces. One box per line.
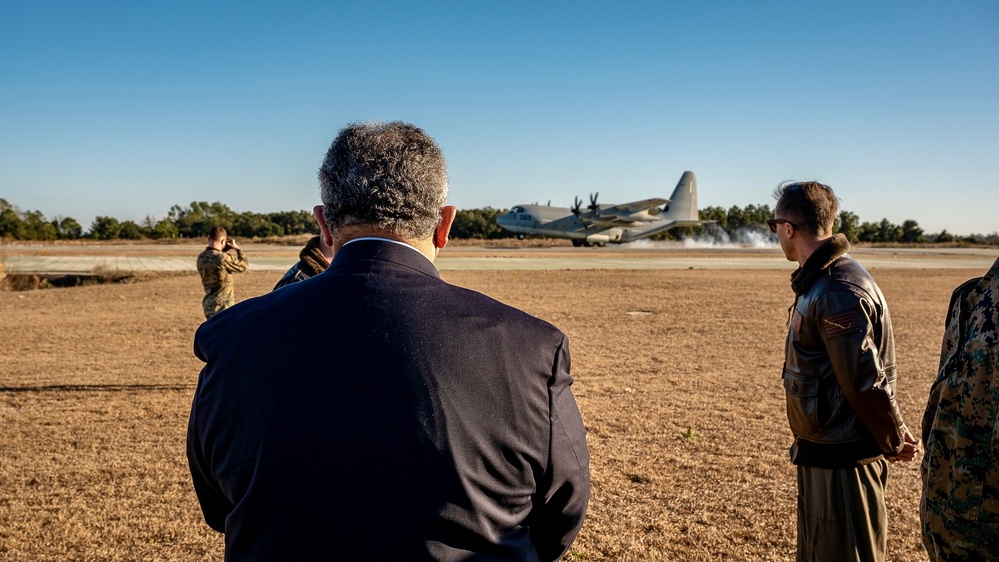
783, 235, 906, 468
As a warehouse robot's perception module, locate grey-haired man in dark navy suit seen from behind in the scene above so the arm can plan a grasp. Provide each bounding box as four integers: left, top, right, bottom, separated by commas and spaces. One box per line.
188, 123, 589, 560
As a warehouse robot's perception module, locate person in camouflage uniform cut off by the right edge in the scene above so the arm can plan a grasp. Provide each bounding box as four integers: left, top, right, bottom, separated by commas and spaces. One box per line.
919, 255, 999, 562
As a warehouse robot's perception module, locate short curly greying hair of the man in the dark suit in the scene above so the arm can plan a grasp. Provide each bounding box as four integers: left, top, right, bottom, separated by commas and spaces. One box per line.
319, 121, 447, 240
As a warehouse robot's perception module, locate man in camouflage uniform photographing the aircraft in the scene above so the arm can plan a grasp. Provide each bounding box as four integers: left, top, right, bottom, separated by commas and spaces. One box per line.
198, 226, 250, 320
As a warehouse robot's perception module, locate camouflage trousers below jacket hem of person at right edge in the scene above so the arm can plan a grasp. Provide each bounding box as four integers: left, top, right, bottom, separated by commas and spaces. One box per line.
919, 498, 999, 562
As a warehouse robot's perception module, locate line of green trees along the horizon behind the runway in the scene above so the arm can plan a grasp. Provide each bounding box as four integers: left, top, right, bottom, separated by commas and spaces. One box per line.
0, 198, 999, 244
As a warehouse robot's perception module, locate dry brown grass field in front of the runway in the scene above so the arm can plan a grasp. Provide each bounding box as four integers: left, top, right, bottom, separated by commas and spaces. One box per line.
0, 250, 982, 562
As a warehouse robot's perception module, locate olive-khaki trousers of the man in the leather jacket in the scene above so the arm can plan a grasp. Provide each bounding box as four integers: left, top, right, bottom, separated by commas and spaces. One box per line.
797, 459, 888, 562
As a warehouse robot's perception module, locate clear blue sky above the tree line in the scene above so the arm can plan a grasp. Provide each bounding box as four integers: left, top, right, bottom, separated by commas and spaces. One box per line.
0, 0, 999, 234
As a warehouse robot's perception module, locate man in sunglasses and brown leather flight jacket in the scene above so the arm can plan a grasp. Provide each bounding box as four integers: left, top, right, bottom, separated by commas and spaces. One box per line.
768, 182, 919, 562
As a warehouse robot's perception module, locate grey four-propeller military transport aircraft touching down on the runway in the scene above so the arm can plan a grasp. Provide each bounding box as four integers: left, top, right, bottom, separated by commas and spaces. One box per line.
496, 168, 713, 243
